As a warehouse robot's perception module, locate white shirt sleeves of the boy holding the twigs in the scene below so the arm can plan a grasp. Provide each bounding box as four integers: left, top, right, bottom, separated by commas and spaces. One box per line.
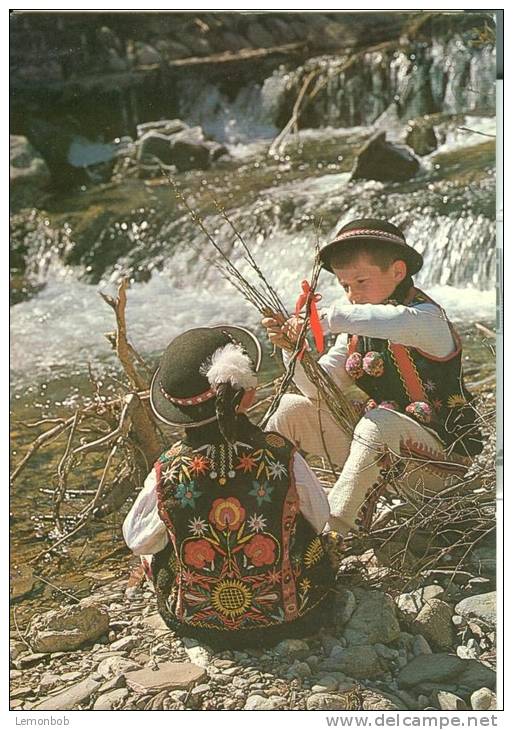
283, 302, 456, 398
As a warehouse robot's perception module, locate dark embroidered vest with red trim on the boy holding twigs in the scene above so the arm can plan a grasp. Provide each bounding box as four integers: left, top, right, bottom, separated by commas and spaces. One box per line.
346, 288, 483, 456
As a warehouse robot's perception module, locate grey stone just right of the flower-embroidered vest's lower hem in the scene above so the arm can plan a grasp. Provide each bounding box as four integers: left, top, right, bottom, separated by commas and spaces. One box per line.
344, 589, 401, 645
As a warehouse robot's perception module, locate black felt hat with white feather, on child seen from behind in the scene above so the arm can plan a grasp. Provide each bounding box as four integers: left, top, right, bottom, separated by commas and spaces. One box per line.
150, 325, 262, 426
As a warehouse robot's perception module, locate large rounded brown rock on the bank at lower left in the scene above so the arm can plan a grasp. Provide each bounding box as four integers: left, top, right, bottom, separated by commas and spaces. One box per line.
28, 604, 109, 652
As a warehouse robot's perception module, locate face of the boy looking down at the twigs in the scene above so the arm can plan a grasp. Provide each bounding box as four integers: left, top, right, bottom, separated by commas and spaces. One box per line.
333, 254, 407, 304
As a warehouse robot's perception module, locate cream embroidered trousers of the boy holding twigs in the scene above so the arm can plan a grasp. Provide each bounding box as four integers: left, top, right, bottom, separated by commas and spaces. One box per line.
268, 395, 466, 533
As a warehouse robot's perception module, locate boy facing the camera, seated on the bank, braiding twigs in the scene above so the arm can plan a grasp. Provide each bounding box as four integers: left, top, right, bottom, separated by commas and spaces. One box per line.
263, 218, 482, 534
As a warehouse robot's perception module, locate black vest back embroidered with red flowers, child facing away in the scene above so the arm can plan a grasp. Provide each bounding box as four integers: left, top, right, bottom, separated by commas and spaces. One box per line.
155, 429, 333, 636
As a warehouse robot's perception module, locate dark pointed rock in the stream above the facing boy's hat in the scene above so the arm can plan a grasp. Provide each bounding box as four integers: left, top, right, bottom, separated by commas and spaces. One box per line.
351, 132, 420, 182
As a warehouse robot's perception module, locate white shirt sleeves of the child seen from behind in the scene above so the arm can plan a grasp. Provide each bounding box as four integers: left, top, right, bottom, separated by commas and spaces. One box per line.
123, 452, 330, 555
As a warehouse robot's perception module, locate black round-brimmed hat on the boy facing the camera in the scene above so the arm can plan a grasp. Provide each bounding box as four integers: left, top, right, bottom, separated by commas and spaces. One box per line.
320, 218, 424, 274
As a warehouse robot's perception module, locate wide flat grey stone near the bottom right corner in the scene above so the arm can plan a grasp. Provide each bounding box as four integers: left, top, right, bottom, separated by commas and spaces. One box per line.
397, 654, 496, 690
